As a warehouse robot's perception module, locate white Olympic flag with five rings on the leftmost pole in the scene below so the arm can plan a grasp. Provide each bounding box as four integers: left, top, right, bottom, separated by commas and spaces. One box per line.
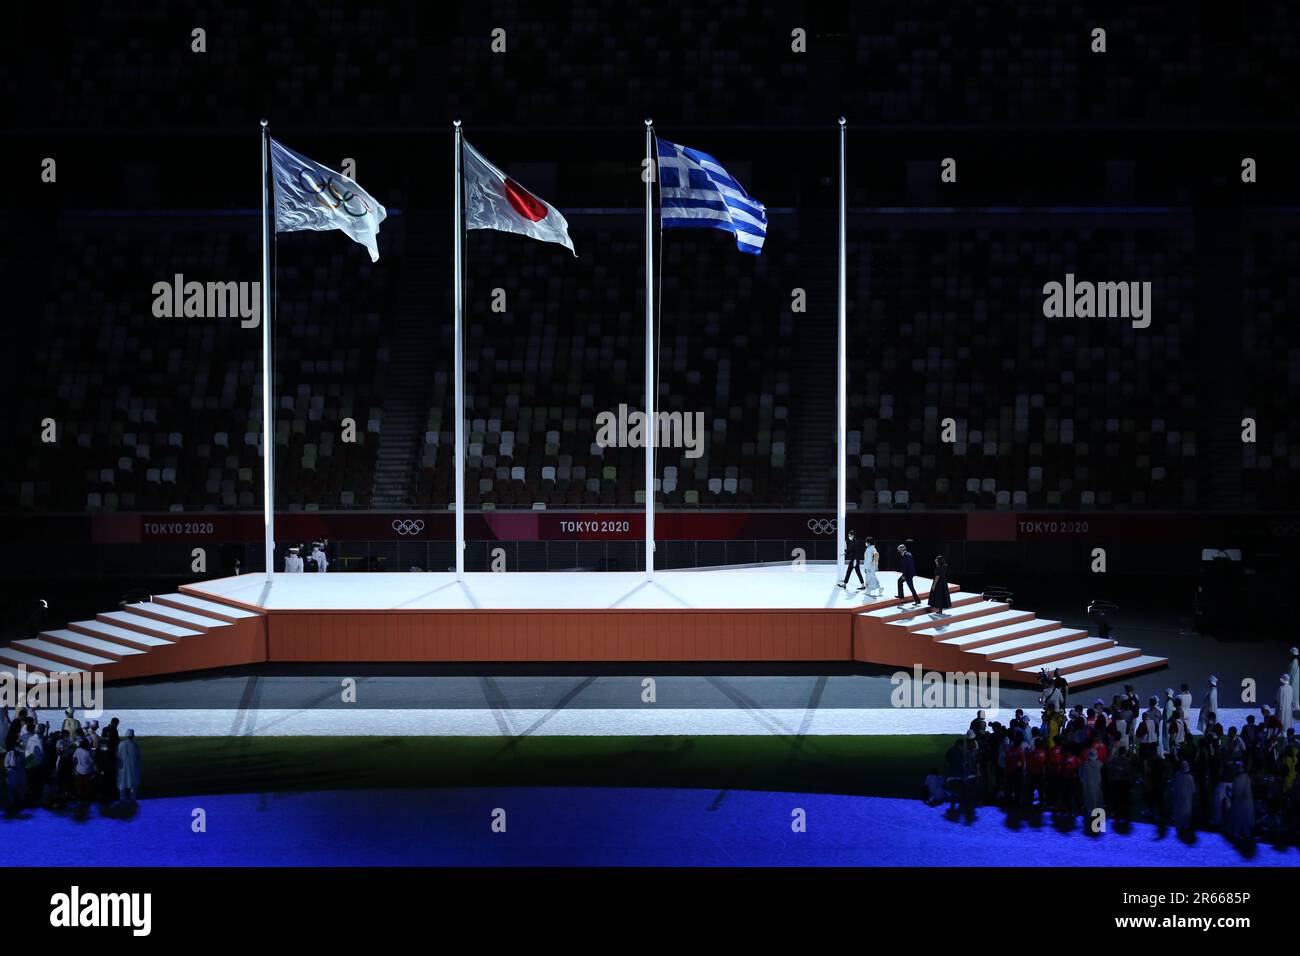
270, 139, 389, 263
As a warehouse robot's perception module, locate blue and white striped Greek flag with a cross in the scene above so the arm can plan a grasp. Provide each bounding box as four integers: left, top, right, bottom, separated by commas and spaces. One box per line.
655, 137, 767, 255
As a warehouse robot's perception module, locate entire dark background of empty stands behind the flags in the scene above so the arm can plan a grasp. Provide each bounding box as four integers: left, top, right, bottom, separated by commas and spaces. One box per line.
0, 0, 1300, 634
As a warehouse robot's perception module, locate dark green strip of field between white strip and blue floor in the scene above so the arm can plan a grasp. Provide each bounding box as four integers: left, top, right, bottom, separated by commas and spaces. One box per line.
142, 735, 956, 797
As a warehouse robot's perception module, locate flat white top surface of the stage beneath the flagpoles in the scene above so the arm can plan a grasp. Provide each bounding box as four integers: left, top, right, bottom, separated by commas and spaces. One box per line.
186, 564, 930, 611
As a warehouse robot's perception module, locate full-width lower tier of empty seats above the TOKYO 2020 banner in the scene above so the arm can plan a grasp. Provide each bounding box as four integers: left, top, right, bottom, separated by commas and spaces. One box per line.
4, 213, 1300, 511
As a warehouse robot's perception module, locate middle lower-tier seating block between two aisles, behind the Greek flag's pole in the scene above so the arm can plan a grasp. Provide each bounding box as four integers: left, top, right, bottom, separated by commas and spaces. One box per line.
415, 216, 796, 509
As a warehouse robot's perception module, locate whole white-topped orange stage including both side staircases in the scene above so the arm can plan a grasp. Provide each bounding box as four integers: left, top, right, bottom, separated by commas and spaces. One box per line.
15, 564, 1166, 685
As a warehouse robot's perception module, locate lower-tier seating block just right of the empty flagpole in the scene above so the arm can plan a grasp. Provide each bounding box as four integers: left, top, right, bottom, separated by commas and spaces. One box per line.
849, 217, 1199, 510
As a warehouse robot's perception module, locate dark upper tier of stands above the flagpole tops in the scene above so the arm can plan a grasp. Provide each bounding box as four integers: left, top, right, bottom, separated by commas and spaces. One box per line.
8, 0, 1300, 126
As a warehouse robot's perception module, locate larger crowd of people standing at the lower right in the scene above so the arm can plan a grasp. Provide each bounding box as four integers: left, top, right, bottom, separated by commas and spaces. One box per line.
926, 658, 1300, 843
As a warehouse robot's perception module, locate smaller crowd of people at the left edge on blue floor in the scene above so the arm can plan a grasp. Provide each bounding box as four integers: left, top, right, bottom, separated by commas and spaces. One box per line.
0, 708, 140, 813
